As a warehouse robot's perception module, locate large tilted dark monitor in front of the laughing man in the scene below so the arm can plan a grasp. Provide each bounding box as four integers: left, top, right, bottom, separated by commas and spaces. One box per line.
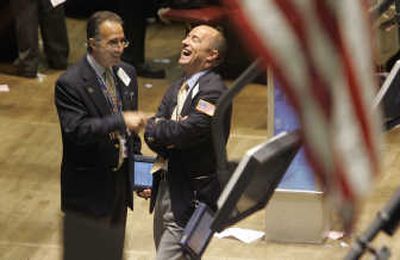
211, 131, 301, 231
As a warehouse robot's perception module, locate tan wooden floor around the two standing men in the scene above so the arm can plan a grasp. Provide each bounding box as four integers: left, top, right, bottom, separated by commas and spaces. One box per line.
0, 19, 400, 260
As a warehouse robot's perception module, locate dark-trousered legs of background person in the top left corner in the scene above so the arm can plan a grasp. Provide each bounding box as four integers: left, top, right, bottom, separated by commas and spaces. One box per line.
10, 0, 69, 78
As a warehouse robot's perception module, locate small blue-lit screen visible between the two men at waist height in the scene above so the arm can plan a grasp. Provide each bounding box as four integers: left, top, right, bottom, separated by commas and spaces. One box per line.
132, 155, 155, 190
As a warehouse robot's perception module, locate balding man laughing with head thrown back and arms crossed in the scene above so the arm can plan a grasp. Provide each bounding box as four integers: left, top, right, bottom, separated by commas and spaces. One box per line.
143, 25, 230, 260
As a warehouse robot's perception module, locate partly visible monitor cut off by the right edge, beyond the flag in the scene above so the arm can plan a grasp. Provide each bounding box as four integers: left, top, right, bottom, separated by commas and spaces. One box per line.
374, 60, 400, 130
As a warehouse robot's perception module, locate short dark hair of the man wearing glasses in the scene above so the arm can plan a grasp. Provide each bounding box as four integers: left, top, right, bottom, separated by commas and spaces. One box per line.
86, 11, 123, 52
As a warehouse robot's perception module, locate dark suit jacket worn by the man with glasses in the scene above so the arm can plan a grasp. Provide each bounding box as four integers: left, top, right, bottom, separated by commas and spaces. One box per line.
55, 57, 140, 216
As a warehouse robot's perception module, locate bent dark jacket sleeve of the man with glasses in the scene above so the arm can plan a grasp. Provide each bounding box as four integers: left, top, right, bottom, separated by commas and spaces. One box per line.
55, 80, 126, 144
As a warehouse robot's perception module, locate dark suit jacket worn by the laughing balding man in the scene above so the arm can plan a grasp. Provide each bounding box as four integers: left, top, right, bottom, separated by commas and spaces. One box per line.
145, 72, 231, 225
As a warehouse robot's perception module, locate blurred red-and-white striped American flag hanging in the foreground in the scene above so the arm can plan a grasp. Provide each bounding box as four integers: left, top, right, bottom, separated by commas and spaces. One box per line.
225, 0, 381, 230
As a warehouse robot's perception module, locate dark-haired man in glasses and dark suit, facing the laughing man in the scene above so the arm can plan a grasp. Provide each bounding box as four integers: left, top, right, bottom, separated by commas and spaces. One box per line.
55, 11, 145, 260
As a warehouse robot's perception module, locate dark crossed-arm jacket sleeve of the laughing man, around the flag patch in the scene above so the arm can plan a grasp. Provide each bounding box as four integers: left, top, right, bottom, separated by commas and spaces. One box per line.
147, 86, 223, 149
